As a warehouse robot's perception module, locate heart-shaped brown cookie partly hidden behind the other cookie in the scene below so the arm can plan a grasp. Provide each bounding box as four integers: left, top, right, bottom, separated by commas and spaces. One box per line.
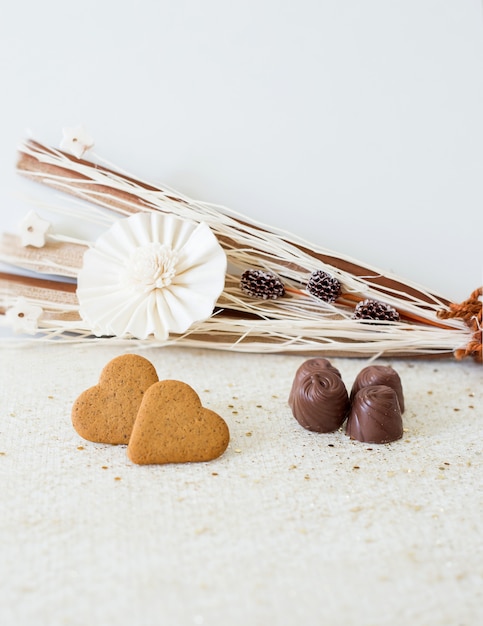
72, 354, 158, 444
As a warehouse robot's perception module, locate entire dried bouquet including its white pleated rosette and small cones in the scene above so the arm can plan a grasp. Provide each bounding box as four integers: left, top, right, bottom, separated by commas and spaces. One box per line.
0, 137, 482, 362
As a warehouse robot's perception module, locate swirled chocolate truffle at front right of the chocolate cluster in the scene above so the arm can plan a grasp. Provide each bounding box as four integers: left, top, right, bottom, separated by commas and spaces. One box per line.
346, 385, 403, 443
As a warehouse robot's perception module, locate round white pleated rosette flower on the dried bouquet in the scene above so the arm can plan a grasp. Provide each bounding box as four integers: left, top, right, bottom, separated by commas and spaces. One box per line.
77, 212, 227, 340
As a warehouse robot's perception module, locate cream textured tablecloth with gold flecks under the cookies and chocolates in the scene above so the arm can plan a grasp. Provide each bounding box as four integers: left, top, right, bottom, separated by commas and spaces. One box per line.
0, 343, 483, 626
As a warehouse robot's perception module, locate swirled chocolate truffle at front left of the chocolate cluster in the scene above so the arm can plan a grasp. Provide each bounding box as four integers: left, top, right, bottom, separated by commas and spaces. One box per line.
289, 367, 349, 433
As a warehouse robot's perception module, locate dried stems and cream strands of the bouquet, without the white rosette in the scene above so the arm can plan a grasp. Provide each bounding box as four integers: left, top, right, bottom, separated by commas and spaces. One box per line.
0, 141, 482, 361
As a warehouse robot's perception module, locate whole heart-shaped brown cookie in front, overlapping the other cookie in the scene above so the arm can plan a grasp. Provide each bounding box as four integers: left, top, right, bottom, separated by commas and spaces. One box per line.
127, 380, 230, 465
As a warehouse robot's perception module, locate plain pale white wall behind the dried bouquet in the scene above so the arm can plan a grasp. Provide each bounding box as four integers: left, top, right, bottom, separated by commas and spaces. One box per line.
0, 0, 483, 300
